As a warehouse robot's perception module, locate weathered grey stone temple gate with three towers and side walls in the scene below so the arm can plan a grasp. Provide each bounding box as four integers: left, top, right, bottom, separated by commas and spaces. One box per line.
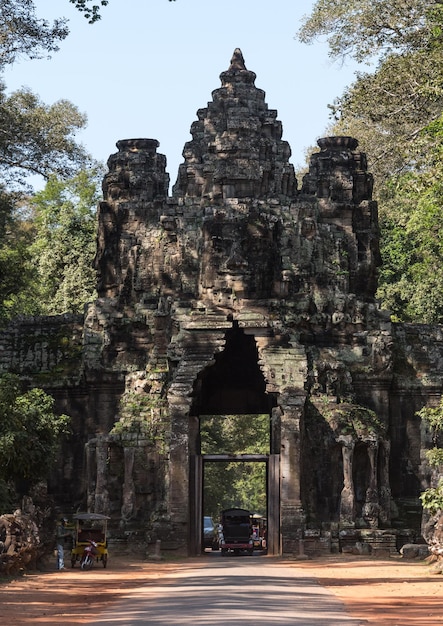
1, 50, 443, 554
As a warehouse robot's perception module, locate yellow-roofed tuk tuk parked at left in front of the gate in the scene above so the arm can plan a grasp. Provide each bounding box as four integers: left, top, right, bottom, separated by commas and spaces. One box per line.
71, 513, 110, 567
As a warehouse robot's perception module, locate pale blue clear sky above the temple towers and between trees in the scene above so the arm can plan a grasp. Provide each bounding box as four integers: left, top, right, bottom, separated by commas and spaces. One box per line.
5, 0, 362, 187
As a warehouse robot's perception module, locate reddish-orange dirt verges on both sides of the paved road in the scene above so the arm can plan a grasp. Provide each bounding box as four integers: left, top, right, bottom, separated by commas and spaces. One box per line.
0, 555, 443, 626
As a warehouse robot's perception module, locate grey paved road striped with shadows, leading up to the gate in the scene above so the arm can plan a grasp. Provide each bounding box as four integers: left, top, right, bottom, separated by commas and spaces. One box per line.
88, 553, 367, 626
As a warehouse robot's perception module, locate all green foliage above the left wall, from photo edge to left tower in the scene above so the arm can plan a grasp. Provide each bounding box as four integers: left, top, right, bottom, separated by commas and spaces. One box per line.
0, 169, 101, 324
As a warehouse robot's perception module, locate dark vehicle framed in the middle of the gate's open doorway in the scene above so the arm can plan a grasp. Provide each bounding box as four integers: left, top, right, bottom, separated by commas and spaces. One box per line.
220, 508, 254, 555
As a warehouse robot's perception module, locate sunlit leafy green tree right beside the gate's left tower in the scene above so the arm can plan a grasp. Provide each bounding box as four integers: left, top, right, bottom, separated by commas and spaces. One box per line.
29, 170, 101, 314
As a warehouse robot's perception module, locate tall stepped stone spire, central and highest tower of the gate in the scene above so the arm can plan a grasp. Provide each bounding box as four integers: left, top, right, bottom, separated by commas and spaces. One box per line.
174, 48, 297, 203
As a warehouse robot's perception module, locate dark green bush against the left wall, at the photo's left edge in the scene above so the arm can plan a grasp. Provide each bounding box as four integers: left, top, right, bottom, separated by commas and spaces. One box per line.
0, 374, 70, 482
